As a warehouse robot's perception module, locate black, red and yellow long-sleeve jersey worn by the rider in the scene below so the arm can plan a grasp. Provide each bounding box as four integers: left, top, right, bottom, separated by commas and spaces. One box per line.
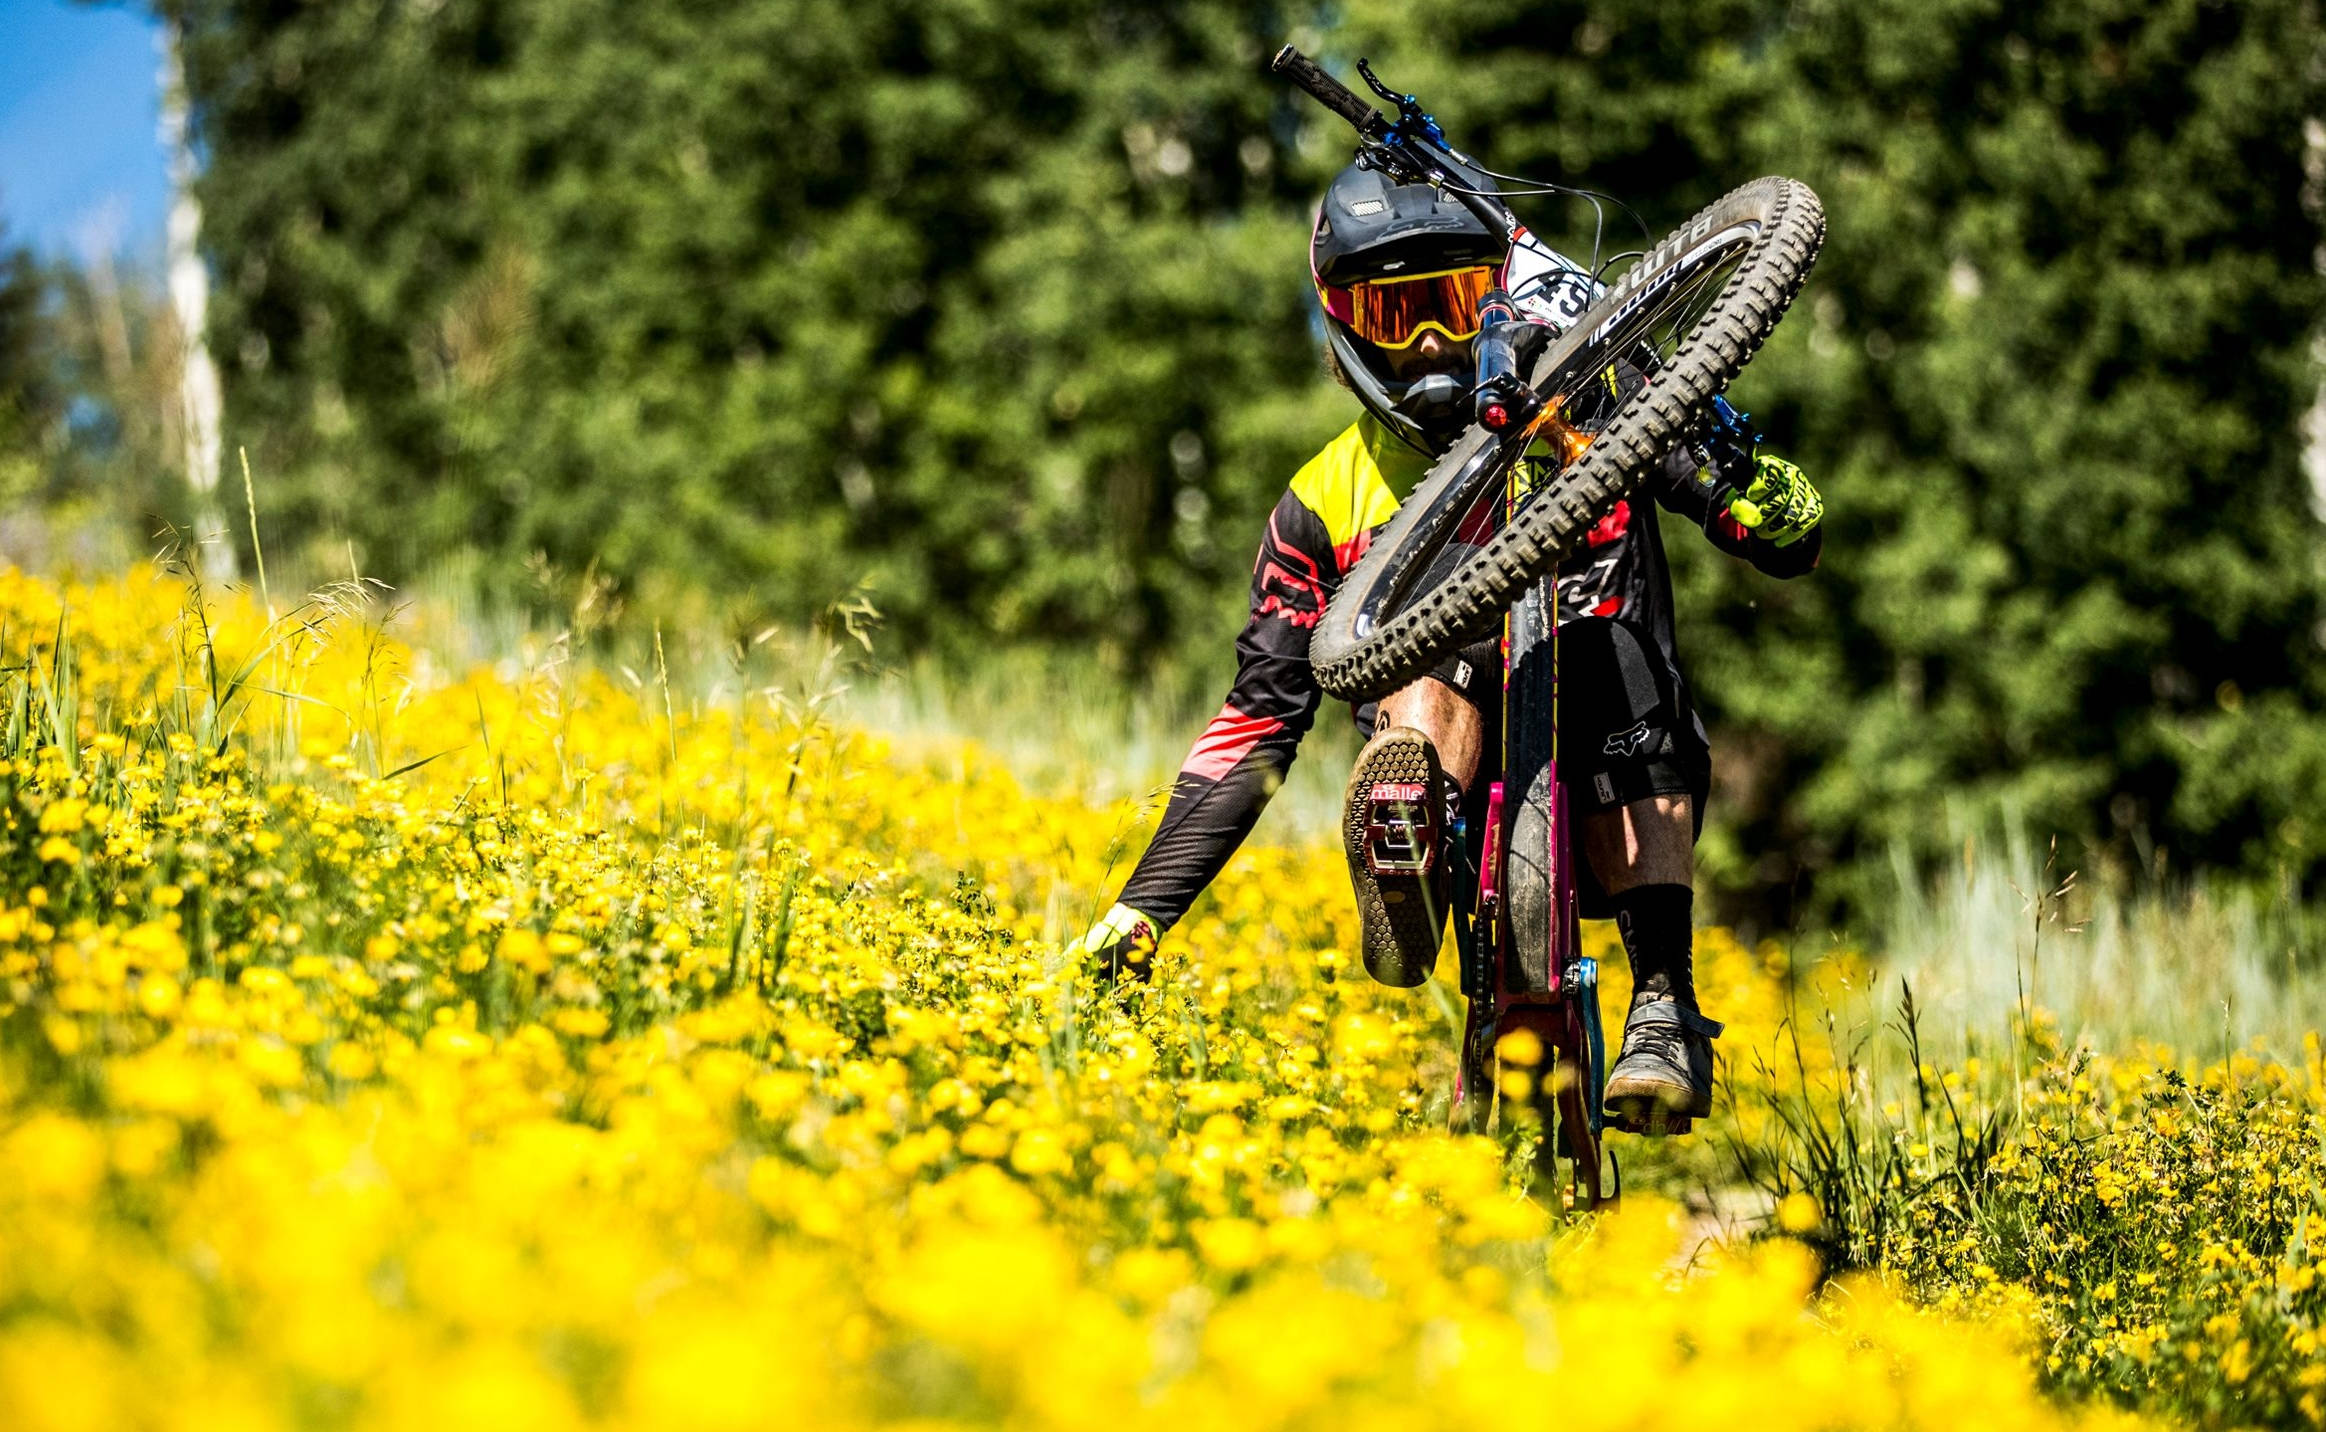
1121, 416, 1819, 928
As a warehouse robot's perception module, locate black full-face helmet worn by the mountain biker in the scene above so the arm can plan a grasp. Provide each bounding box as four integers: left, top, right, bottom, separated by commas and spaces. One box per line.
1310, 165, 1510, 451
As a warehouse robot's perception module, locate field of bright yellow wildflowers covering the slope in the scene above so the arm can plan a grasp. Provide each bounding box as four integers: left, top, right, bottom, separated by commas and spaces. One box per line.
0, 564, 2270, 1432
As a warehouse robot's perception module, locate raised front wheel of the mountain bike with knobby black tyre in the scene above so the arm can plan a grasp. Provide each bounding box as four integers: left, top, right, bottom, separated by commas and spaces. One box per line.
1310, 177, 1826, 702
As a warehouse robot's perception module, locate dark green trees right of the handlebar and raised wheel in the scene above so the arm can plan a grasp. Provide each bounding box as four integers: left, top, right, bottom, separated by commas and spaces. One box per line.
1351, 0, 2326, 915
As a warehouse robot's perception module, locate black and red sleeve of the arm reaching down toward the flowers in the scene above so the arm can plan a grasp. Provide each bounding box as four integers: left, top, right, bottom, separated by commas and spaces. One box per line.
1102, 493, 1340, 935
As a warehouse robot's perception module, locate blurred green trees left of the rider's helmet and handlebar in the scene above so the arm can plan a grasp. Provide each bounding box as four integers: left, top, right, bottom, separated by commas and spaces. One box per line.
179, 0, 1335, 651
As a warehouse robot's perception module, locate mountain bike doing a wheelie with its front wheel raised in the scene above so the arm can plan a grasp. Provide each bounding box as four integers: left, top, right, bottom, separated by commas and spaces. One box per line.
1270, 44, 1826, 1209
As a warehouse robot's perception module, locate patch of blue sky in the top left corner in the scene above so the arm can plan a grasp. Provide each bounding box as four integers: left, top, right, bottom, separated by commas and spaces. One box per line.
0, 0, 170, 258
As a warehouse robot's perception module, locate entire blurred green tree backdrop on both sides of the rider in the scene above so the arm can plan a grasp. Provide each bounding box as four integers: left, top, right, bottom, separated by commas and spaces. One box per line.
163, 0, 2326, 914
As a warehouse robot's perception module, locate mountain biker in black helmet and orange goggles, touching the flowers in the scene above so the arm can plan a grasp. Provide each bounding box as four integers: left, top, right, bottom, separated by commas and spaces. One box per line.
1072, 165, 1824, 1127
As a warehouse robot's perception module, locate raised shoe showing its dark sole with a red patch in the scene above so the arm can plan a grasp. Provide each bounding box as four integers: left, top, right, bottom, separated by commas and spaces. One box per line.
1342, 725, 1454, 988
